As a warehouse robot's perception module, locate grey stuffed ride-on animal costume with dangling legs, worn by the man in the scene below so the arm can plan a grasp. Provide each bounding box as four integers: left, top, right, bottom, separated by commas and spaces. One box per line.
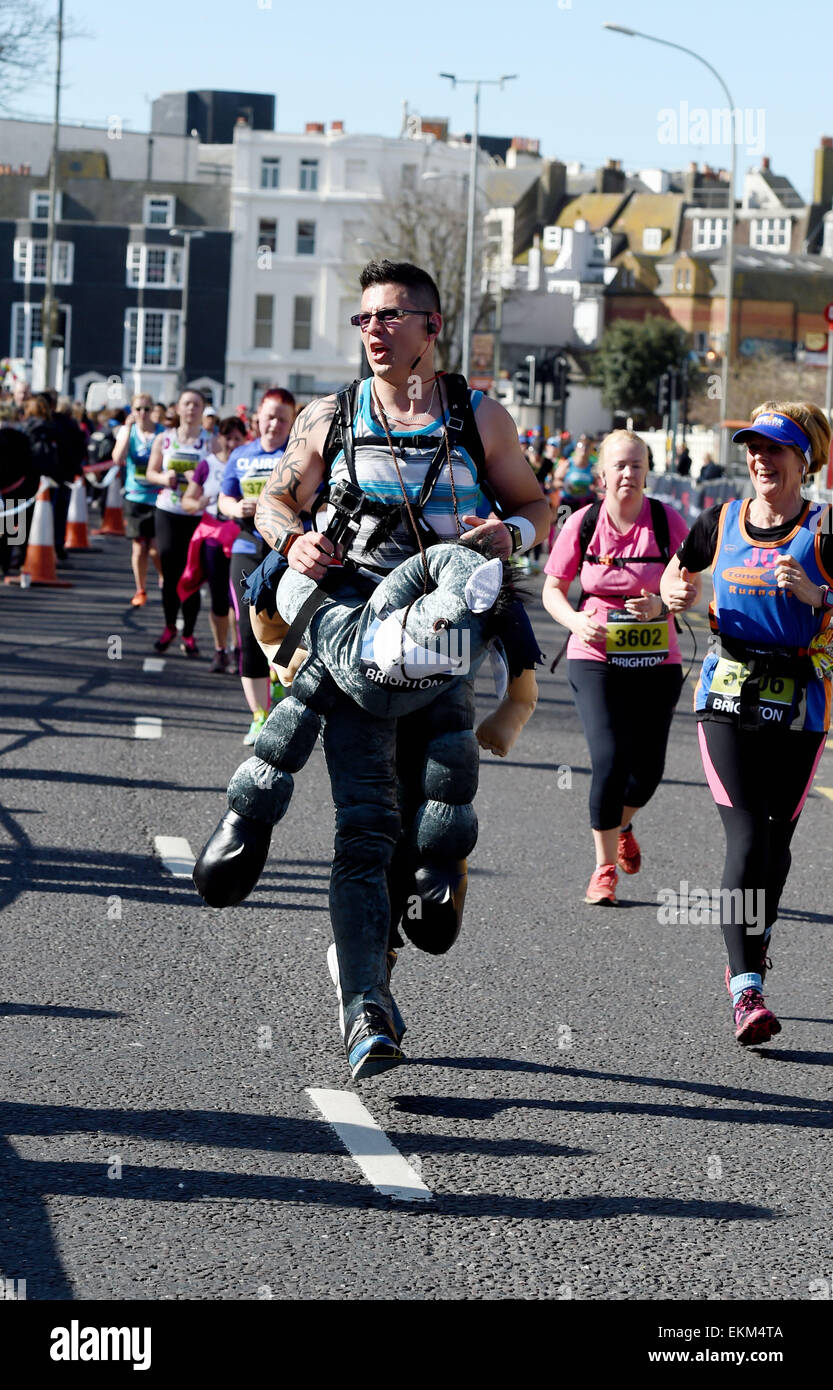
195, 533, 503, 1009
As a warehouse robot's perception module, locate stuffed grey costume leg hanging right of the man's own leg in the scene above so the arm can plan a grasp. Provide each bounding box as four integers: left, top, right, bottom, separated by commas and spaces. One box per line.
399, 682, 480, 955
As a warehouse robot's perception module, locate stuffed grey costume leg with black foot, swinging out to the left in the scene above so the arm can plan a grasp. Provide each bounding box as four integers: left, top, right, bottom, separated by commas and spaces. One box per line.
193, 678, 321, 908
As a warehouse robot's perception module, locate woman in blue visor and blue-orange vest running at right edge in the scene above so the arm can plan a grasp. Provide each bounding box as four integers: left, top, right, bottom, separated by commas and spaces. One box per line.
661, 402, 833, 1045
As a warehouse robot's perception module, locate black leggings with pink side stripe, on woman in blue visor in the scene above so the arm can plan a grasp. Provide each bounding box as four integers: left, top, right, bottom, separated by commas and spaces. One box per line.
698, 719, 826, 974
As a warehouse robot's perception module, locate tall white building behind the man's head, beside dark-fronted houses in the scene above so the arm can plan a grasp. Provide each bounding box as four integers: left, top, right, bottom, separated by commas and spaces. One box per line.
225, 120, 491, 406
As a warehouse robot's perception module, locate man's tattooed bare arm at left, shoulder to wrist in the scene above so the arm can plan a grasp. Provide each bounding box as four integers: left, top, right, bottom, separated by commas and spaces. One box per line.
254, 396, 335, 546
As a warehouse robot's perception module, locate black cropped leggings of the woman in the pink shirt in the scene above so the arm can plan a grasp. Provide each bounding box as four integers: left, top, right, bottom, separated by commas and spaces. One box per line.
567, 660, 683, 830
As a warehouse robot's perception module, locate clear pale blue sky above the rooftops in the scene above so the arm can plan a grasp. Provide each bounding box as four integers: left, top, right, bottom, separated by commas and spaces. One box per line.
14, 0, 833, 197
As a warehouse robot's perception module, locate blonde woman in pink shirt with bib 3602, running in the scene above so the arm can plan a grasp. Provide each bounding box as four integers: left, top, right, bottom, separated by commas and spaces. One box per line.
542, 430, 688, 904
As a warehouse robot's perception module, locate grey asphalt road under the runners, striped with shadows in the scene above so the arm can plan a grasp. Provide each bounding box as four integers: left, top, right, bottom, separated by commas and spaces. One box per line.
0, 528, 833, 1301
